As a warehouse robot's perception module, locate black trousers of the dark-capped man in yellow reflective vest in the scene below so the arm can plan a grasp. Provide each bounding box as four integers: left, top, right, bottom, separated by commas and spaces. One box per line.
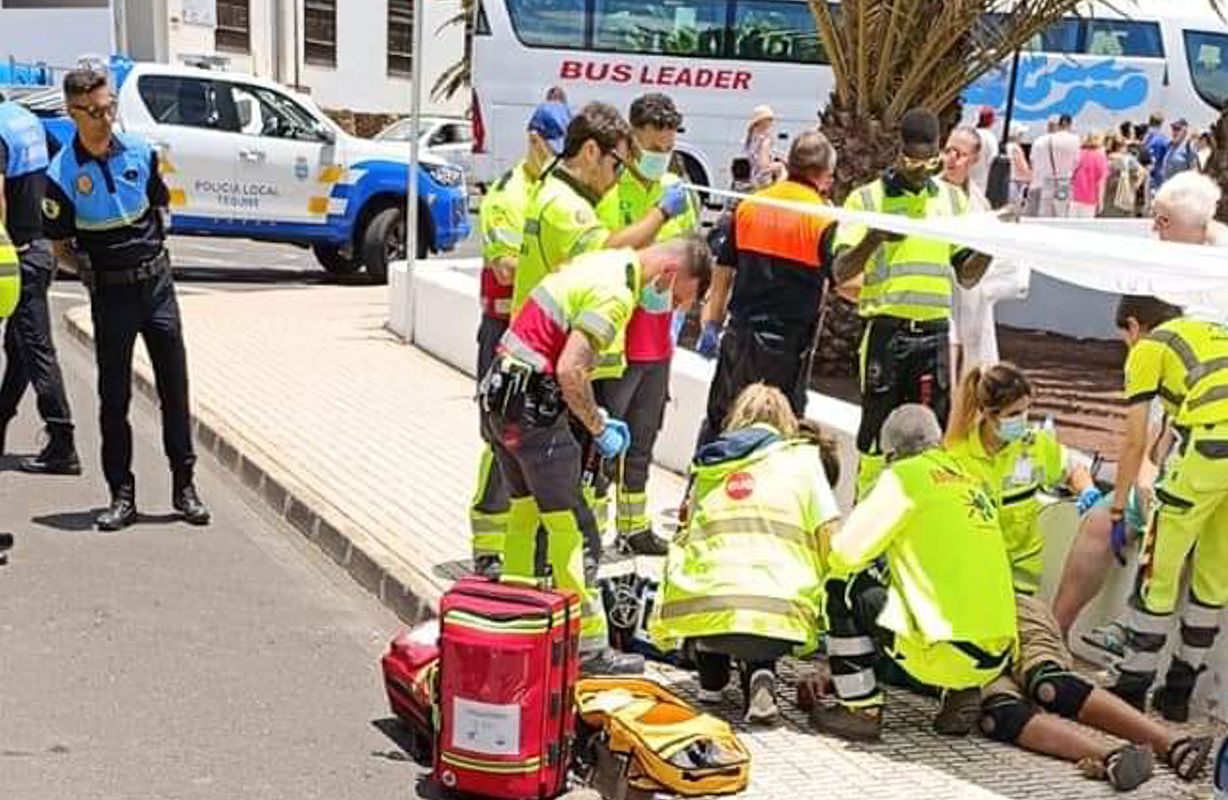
857, 317, 950, 456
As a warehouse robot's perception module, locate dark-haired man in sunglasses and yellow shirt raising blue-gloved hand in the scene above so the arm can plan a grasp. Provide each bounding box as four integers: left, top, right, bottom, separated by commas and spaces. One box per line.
512, 102, 689, 317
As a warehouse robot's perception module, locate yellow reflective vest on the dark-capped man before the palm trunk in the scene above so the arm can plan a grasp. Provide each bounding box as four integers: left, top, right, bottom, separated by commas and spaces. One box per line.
836, 178, 968, 322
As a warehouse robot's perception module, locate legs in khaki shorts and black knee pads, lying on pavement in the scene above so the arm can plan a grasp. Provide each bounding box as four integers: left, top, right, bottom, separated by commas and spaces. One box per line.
981, 595, 1213, 791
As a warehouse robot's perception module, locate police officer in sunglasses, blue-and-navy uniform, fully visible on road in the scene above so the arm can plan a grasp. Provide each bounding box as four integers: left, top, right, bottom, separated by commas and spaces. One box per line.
43, 69, 209, 531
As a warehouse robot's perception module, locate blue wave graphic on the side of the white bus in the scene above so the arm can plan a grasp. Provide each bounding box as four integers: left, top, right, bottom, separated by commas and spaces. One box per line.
964, 55, 1151, 120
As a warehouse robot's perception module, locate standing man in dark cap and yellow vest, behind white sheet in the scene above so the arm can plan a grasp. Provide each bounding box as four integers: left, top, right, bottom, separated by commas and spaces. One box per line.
833, 109, 990, 496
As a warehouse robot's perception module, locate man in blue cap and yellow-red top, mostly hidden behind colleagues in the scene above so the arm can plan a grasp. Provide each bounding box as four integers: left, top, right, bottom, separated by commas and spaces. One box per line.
469, 103, 571, 574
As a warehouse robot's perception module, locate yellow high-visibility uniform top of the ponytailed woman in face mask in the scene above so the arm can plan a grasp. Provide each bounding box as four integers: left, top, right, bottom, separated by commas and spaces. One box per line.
947, 428, 1067, 595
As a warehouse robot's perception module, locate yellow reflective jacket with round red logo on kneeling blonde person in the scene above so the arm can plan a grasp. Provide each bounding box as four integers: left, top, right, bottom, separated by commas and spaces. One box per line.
648, 440, 824, 653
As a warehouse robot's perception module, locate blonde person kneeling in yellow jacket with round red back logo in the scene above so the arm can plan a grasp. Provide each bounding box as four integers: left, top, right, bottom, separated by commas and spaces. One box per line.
648, 383, 840, 723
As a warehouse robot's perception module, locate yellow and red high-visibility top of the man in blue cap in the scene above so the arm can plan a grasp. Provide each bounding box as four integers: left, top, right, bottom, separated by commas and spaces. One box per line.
478, 161, 537, 320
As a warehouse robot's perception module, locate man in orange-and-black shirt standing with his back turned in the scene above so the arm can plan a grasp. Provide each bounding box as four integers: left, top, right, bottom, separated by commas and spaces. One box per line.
699, 130, 836, 454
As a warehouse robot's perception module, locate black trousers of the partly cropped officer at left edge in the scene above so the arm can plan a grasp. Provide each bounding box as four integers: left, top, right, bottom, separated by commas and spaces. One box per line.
0, 240, 72, 430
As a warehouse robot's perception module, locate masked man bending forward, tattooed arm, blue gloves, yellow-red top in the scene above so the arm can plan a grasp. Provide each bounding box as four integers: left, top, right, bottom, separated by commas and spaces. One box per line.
479, 238, 711, 673
